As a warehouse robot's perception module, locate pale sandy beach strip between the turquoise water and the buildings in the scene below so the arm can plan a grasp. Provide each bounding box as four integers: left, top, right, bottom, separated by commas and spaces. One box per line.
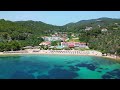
0, 49, 120, 60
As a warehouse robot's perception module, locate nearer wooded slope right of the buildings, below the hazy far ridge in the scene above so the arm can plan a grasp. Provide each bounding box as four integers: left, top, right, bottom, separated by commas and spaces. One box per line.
76, 17, 120, 55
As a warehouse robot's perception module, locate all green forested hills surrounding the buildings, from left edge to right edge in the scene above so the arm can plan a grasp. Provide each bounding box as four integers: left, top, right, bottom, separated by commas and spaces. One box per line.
0, 18, 120, 55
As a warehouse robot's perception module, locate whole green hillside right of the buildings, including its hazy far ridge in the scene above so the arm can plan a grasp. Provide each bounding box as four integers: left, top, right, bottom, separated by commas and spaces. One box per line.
65, 18, 120, 55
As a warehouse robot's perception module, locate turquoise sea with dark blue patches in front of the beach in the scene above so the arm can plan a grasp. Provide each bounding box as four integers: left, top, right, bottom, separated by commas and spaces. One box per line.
0, 55, 120, 79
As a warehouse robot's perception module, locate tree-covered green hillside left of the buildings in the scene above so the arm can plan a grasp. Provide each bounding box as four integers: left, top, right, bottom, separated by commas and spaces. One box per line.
0, 19, 64, 51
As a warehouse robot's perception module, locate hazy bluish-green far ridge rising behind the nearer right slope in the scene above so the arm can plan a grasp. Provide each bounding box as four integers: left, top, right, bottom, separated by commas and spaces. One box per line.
64, 17, 120, 32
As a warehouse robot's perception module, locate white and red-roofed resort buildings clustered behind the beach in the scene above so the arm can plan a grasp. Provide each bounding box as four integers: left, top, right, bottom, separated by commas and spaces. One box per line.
39, 32, 88, 49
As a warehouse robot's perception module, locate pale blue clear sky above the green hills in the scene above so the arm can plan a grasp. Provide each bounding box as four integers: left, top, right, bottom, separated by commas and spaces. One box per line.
0, 11, 120, 26
